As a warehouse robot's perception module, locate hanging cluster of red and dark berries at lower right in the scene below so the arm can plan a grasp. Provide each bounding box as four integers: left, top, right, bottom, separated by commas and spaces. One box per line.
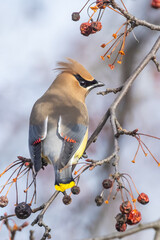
95, 179, 149, 232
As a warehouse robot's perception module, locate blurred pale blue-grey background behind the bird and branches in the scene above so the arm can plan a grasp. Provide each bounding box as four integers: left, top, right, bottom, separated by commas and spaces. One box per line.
0, 0, 160, 240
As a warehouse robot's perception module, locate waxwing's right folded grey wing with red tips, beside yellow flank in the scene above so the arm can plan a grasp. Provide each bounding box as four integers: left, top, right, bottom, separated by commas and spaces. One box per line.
56, 117, 88, 170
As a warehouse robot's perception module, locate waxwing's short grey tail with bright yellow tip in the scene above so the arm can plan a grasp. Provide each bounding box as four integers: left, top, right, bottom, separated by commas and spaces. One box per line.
55, 166, 75, 192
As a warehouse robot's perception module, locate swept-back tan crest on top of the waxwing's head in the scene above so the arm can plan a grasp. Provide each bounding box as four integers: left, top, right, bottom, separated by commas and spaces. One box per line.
56, 58, 94, 81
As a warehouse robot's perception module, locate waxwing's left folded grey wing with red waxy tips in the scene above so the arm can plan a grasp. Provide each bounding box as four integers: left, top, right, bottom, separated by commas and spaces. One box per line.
29, 117, 48, 172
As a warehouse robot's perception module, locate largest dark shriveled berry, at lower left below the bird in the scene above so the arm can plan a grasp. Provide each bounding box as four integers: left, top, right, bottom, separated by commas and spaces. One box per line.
15, 202, 32, 219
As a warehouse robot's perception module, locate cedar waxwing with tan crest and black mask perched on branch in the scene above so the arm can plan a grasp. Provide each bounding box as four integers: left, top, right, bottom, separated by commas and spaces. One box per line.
29, 58, 104, 192
